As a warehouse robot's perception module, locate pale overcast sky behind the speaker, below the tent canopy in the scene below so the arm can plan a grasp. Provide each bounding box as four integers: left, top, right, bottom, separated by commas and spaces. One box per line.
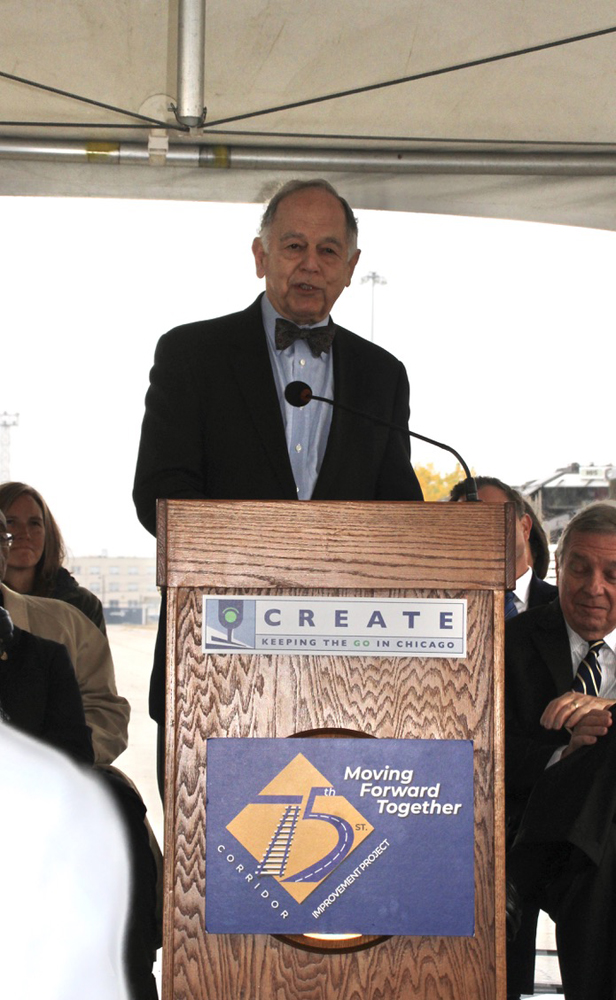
0, 197, 616, 555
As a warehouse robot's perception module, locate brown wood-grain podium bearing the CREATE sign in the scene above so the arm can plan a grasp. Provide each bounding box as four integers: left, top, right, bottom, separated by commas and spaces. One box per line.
158, 501, 515, 1000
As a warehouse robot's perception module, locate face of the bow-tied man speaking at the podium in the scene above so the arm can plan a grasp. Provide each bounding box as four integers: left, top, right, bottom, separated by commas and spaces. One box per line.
252, 188, 359, 325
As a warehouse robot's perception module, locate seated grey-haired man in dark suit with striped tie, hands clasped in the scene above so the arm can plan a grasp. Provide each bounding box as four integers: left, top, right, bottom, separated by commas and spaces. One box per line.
505, 501, 616, 1000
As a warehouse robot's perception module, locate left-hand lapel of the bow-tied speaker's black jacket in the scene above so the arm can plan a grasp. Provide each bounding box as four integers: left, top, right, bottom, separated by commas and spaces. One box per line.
229, 296, 297, 500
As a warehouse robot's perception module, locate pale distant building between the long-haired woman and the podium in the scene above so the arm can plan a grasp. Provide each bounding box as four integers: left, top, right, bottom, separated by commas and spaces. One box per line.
67, 554, 160, 625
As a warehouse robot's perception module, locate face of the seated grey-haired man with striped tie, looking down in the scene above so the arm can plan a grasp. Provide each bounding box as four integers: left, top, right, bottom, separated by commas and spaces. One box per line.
557, 531, 616, 642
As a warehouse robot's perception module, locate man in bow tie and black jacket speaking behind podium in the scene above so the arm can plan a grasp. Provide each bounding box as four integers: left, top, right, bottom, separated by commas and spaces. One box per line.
133, 180, 423, 772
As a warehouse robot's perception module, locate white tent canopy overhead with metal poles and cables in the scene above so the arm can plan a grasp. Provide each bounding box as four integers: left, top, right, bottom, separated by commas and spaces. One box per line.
0, 0, 616, 229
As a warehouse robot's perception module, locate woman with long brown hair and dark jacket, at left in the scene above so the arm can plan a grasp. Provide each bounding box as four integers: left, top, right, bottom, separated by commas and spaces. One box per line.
0, 483, 106, 633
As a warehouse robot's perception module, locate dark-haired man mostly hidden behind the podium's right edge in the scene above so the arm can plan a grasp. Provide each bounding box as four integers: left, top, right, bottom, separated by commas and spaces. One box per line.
449, 476, 558, 619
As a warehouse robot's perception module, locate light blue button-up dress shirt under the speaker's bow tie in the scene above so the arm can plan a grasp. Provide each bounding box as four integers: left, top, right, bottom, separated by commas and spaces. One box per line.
261, 295, 334, 500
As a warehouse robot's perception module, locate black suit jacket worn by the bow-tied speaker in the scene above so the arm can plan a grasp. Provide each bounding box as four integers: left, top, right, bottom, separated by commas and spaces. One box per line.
133, 297, 422, 533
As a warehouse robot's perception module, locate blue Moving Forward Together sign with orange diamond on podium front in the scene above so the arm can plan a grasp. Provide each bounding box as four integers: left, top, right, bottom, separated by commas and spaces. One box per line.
205, 739, 475, 936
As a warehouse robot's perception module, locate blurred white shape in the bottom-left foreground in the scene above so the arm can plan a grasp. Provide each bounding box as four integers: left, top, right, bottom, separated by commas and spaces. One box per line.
0, 722, 129, 1000
